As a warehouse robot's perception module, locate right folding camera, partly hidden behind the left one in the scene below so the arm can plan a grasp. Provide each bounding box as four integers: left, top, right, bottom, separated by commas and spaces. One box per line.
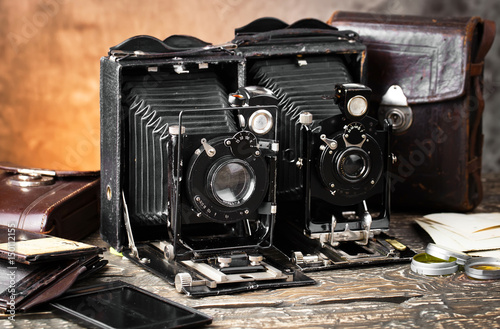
233, 18, 413, 270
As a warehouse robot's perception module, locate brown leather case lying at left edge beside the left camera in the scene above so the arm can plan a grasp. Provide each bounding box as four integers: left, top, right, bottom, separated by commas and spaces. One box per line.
0, 163, 100, 240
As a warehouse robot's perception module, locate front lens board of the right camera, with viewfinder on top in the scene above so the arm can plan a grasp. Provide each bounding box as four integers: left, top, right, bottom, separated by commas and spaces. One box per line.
299, 83, 390, 246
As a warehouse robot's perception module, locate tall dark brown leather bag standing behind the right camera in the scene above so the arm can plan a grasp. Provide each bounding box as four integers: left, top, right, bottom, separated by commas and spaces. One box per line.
328, 11, 495, 211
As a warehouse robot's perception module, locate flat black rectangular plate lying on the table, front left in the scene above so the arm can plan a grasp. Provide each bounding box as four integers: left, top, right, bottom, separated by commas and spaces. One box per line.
50, 281, 212, 329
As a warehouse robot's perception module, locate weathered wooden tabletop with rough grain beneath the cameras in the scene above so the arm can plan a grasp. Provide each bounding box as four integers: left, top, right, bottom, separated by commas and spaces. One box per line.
0, 175, 500, 328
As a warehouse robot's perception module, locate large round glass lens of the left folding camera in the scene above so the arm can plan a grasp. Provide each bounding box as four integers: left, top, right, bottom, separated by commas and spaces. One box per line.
210, 159, 255, 207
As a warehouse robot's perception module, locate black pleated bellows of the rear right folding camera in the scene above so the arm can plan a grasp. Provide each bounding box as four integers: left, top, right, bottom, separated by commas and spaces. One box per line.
249, 55, 354, 198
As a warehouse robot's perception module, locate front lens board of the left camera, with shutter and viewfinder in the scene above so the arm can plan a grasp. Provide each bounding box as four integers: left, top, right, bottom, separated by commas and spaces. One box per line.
167, 87, 279, 259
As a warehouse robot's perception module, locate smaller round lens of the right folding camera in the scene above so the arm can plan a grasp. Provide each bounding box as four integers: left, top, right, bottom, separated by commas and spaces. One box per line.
337, 148, 370, 182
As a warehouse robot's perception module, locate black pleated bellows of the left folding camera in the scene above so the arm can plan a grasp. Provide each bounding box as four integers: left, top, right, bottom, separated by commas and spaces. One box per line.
124, 71, 236, 224
